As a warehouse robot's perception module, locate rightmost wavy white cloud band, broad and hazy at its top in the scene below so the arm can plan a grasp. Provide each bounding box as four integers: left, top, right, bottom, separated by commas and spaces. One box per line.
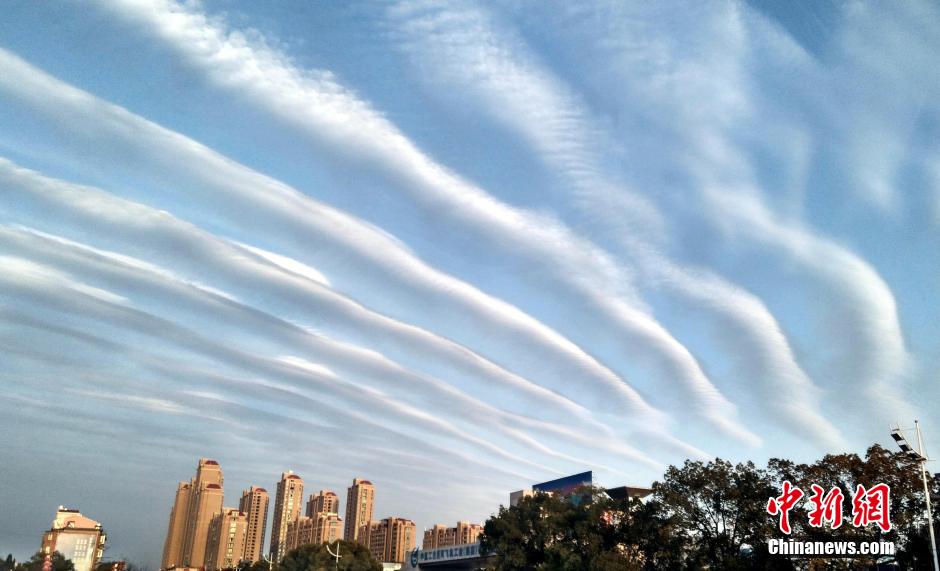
506, 0, 909, 428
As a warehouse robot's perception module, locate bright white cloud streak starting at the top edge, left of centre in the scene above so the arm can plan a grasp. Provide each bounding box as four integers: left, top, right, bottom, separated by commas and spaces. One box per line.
84, 0, 759, 444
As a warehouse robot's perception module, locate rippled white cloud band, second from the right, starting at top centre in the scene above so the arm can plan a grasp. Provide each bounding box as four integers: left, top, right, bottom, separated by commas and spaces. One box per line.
389, 2, 841, 447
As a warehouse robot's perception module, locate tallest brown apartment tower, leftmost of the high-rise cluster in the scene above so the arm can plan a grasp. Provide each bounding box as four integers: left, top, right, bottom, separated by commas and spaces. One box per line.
163, 458, 223, 569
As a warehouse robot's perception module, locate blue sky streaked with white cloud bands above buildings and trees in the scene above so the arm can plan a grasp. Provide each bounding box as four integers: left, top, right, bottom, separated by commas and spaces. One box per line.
0, 0, 940, 566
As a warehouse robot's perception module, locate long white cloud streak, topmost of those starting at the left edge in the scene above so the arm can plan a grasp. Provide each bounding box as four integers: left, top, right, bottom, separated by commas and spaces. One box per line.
0, 51, 676, 434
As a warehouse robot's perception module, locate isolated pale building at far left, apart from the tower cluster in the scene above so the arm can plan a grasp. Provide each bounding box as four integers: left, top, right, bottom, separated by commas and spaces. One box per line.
40, 506, 106, 571
